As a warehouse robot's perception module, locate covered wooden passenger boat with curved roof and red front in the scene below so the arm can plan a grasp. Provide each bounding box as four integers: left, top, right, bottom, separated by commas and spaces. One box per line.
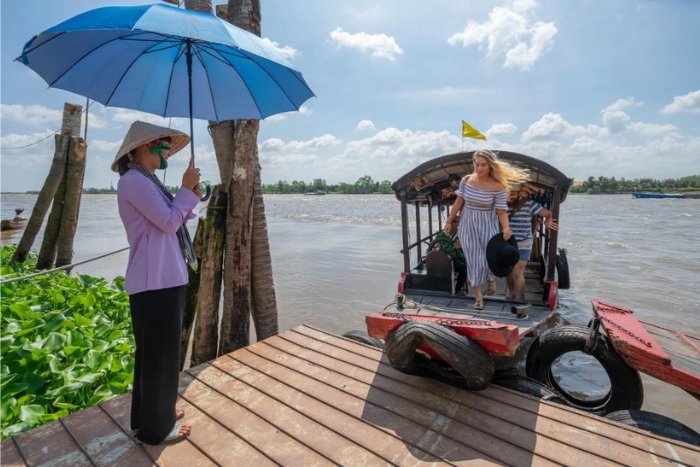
366, 152, 573, 358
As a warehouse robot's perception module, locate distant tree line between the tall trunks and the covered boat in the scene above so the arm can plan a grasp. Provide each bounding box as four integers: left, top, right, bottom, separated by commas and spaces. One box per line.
263, 175, 393, 195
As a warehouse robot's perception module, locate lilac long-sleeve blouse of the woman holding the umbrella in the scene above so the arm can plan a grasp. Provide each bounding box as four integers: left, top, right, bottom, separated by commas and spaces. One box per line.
117, 170, 199, 295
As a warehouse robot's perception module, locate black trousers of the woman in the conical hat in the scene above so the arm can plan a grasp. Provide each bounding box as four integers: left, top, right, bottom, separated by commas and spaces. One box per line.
129, 285, 185, 444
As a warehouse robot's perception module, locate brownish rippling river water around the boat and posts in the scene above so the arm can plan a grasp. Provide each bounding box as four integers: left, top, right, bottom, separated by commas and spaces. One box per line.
1, 194, 700, 432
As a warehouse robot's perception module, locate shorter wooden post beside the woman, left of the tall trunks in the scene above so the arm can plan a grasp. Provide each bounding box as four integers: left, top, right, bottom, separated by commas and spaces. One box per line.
191, 186, 227, 366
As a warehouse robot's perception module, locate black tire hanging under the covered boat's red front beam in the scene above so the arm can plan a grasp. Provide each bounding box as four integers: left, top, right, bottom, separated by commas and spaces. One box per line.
386, 321, 494, 390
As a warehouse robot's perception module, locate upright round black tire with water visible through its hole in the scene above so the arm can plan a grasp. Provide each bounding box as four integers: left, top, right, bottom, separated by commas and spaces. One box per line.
526, 326, 644, 415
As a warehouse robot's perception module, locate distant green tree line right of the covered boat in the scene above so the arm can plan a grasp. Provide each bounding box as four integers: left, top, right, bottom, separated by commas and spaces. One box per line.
569, 175, 700, 194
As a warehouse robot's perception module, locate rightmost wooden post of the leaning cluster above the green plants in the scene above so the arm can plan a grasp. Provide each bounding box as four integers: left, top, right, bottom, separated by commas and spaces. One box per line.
56, 136, 87, 267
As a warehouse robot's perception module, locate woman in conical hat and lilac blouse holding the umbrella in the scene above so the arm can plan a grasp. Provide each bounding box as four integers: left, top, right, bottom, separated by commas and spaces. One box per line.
112, 121, 202, 444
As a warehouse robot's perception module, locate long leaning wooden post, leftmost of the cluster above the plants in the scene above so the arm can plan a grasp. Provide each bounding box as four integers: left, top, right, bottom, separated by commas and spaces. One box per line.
10, 103, 83, 263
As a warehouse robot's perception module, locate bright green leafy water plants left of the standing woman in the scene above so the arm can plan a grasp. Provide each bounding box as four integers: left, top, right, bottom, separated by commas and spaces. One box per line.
0, 246, 135, 439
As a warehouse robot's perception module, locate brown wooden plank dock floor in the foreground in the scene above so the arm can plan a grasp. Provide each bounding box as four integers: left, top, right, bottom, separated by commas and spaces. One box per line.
1, 326, 700, 467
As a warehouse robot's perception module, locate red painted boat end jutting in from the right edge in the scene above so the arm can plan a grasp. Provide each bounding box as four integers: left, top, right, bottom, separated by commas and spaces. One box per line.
593, 300, 700, 398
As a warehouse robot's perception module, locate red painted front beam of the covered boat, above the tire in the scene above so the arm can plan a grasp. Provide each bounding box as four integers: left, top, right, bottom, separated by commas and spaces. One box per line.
365, 313, 520, 357
